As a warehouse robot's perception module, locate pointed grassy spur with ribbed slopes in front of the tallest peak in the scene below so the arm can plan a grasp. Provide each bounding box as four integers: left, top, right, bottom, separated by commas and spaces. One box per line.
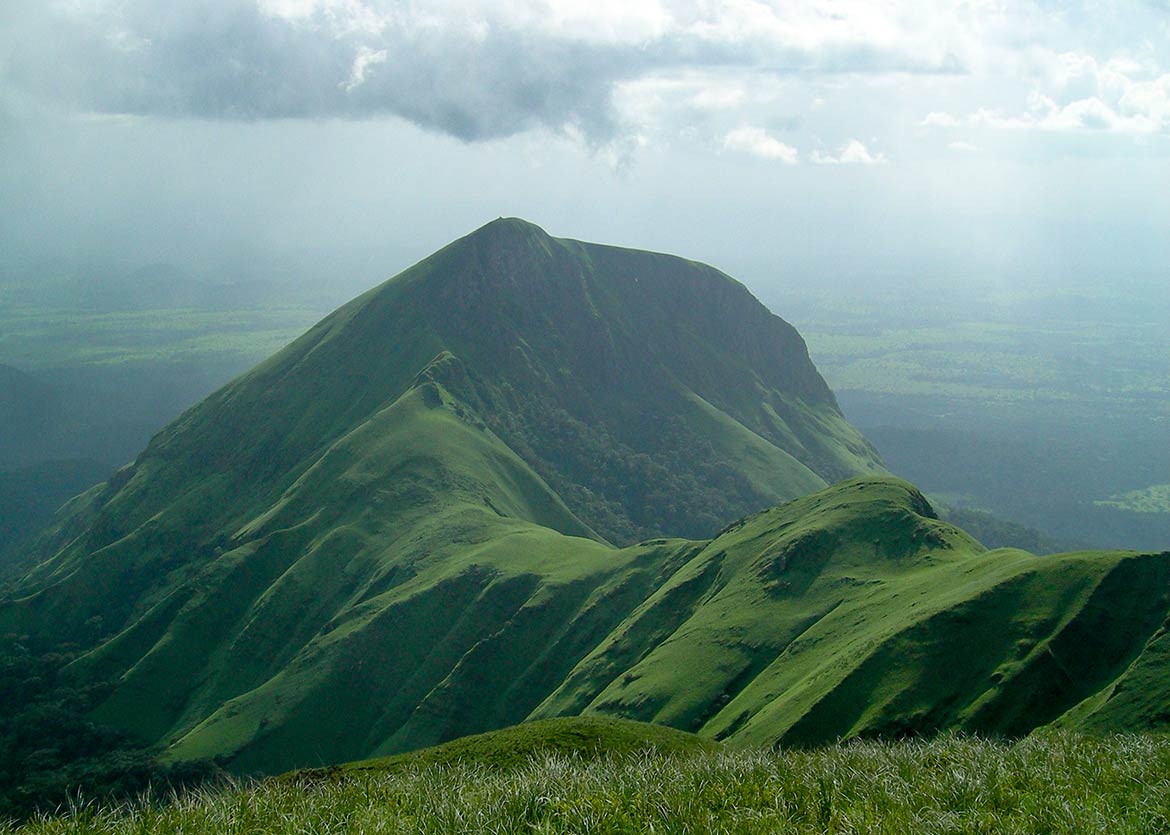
52, 371, 683, 768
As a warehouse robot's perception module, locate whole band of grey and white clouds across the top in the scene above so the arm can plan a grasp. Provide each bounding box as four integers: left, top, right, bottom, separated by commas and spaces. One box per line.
0, 0, 1170, 157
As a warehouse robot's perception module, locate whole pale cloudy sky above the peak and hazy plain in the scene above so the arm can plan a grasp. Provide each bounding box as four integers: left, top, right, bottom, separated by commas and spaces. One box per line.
0, 0, 1170, 292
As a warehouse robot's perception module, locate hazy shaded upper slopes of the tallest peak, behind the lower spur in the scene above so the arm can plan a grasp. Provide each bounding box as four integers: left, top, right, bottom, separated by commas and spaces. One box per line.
75, 221, 876, 551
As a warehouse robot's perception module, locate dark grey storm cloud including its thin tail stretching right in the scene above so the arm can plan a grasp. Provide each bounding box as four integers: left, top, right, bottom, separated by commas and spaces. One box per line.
0, 0, 957, 143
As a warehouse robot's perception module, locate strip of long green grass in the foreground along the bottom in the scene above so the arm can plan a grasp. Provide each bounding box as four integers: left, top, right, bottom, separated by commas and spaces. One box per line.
9, 736, 1170, 835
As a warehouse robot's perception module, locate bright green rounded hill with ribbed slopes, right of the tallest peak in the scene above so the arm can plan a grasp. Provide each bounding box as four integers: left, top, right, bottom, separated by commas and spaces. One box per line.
536, 479, 1170, 744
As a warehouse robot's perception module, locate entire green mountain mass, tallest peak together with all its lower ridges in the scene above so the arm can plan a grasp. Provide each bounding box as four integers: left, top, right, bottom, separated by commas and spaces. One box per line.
0, 220, 1170, 772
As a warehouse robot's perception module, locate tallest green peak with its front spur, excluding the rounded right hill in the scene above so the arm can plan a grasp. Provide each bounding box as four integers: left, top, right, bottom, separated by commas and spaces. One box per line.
0, 220, 880, 772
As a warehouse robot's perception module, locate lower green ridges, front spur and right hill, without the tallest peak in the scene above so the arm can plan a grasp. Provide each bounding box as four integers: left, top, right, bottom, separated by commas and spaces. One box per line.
9, 465, 1170, 772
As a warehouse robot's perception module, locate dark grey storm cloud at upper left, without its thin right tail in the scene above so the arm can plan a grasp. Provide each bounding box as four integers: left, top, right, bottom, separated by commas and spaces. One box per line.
4, 1, 644, 140
